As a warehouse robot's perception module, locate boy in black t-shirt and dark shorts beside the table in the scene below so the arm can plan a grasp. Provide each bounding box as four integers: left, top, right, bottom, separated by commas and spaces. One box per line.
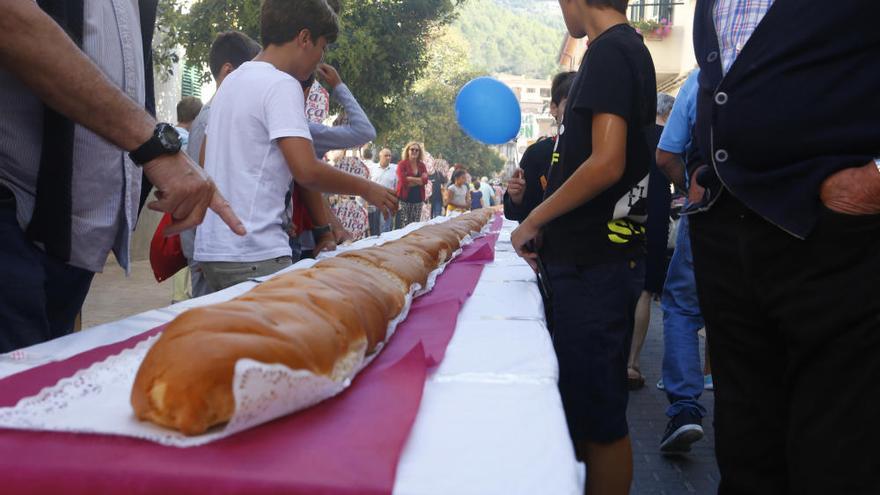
511, 0, 657, 494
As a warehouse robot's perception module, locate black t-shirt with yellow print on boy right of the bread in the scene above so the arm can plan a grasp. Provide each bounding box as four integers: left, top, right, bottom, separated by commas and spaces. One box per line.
541, 24, 657, 265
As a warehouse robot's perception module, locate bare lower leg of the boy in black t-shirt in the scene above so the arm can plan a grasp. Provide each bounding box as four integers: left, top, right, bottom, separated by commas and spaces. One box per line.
578, 435, 632, 495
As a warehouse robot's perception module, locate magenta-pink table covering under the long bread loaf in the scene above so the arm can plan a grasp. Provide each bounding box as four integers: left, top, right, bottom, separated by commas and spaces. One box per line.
0, 218, 500, 495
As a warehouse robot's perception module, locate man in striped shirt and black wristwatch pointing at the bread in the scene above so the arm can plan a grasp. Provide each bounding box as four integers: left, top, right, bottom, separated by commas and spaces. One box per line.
0, 0, 245, 352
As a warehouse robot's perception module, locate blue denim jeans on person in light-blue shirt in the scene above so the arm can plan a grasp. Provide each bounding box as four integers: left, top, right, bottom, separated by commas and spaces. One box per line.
660, 217, 706, 418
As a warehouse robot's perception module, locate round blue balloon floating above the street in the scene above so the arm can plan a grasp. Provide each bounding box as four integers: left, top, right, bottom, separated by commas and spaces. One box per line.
455, 77, 522, 144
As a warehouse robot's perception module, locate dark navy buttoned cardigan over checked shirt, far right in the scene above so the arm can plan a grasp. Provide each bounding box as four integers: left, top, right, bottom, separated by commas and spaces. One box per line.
692, 0, 880, 238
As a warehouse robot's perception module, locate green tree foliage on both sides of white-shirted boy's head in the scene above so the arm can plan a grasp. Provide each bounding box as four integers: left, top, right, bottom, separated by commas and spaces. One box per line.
154, 0, 508, 175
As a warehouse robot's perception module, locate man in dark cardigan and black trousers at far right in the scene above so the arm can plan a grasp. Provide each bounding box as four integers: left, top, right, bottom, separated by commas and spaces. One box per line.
689, 0, 880, 494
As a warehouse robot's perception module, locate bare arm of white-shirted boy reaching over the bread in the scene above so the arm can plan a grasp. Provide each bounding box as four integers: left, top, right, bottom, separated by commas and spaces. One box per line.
278, 137, 397, 216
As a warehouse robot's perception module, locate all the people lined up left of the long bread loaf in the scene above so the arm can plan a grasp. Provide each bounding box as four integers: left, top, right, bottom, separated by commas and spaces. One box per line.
0, 0, 500, 338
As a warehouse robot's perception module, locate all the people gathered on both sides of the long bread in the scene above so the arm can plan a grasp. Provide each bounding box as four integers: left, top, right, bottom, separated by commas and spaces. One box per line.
0, 0, 880, 494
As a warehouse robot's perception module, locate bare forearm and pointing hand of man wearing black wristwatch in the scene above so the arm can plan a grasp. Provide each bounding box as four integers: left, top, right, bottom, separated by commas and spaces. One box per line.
0, 0, 245, 235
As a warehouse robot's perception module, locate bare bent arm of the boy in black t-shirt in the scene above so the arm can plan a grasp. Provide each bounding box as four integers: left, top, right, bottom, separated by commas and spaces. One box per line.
526, 113, 626, 227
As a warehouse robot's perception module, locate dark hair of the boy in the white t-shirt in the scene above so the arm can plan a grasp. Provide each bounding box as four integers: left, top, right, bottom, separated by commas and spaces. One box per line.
260, 0, 339, 46
